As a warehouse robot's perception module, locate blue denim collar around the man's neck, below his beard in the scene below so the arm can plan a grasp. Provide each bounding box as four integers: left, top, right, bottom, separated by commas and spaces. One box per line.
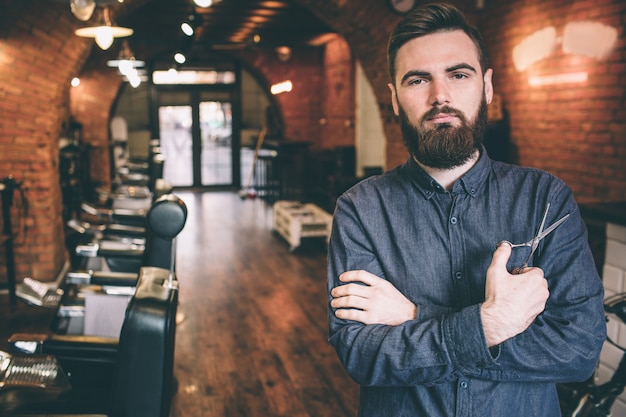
405, 146, 492, 199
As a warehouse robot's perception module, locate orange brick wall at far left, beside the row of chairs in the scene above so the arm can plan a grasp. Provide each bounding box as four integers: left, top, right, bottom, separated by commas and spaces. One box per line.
0, 0, 85, 280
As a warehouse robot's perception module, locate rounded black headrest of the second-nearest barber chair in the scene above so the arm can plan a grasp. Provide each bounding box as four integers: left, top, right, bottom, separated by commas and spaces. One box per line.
146, 194, 187, 239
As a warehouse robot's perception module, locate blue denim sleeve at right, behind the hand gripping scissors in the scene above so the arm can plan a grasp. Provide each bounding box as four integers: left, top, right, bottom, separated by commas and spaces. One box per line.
474, 187, 606, 383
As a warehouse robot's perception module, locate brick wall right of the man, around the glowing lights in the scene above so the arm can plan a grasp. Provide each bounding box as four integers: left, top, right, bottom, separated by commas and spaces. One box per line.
480, 0, 626, 202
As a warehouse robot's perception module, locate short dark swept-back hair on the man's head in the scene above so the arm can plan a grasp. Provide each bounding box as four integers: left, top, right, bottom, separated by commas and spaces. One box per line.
387, 3, 488, 83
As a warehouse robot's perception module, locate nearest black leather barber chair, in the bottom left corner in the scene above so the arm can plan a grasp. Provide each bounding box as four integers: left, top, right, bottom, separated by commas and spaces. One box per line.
0, 267, 178, 417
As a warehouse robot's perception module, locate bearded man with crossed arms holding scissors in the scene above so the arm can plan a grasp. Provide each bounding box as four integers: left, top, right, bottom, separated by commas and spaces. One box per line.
328, 5, 606, 417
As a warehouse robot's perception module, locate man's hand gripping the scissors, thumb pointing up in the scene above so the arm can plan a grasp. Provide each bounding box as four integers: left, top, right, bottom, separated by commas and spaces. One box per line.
480, 243, 550, 347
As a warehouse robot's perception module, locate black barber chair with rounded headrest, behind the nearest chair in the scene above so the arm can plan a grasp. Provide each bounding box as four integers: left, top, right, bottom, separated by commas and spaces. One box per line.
70, 194, 187, 272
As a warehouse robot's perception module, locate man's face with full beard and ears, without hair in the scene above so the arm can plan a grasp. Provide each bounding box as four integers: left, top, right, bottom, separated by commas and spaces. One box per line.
389, 30, 493, 169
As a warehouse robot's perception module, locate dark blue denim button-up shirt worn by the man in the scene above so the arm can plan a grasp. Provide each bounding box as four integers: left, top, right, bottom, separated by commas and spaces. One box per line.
328, 149, 606, 417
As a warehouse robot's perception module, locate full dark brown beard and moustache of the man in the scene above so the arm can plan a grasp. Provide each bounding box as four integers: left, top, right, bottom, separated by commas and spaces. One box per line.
398, 96, 487, 169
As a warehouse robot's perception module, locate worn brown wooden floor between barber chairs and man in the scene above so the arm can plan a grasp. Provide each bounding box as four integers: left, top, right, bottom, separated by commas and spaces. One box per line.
161, 192, 358, 417
